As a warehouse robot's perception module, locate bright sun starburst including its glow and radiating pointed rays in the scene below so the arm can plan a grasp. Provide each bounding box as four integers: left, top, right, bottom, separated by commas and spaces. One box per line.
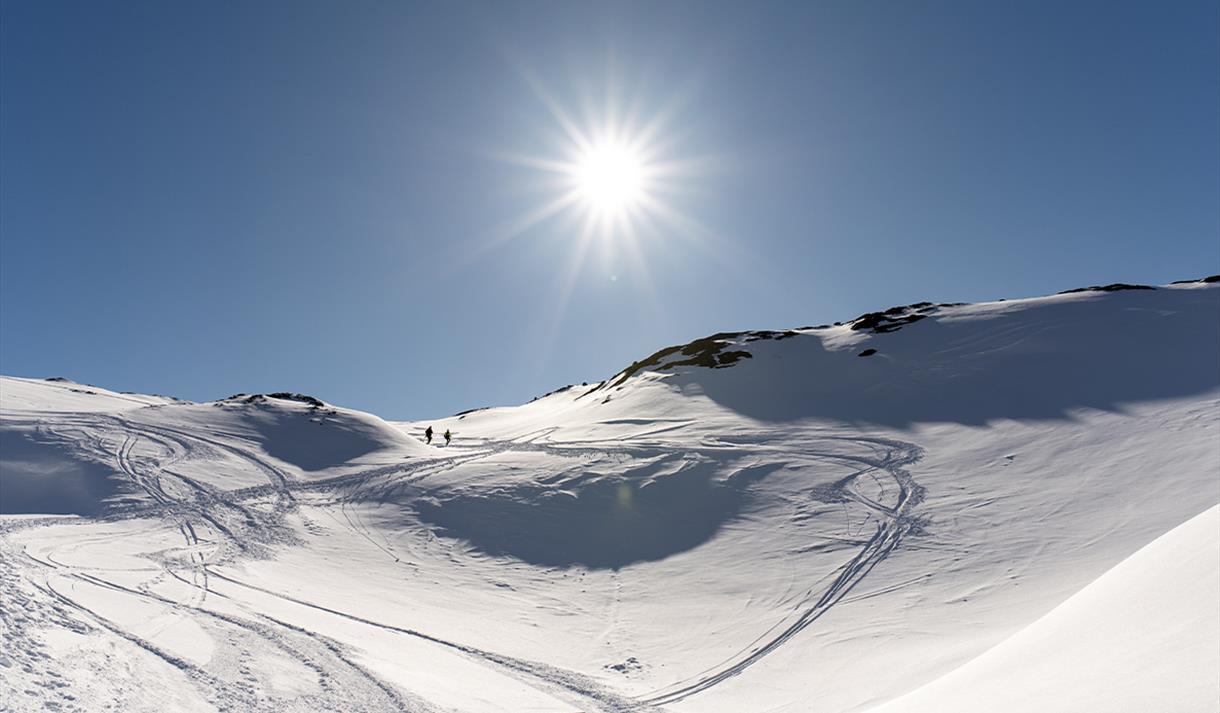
483, 71, 727, 380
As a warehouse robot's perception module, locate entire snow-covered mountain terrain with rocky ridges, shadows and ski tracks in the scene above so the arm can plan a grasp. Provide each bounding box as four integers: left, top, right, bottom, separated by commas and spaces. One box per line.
0, 278, 1220, 713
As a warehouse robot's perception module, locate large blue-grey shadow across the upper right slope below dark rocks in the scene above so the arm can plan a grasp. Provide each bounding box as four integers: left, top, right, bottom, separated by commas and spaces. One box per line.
670, 289, 1220, 427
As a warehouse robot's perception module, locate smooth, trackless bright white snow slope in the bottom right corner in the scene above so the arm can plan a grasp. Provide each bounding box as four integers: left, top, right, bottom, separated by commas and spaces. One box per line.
877, 507, 1220, 713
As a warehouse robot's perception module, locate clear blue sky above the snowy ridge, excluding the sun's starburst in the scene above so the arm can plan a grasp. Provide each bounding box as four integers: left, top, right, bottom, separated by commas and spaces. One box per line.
0, 0, 1220, 419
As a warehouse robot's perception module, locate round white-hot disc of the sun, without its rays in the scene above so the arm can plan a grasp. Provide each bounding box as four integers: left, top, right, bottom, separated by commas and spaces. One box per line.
572, 140, 648, 216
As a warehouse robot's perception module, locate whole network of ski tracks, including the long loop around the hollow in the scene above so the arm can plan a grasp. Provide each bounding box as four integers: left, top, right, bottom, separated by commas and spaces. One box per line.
2, 414, 922, 712
